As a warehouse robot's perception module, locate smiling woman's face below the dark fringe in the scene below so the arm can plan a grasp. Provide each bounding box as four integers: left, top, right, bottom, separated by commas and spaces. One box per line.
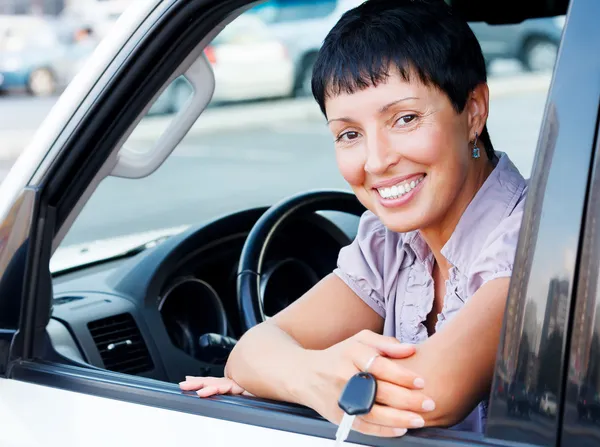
325, 75, 485, 232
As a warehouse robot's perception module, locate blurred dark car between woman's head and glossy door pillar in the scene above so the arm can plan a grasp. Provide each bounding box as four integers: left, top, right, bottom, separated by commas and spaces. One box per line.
471, 16, 565, 71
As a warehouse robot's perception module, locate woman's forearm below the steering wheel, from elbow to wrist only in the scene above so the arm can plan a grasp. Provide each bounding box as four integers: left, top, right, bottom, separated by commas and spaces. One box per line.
225, 322, 311, 404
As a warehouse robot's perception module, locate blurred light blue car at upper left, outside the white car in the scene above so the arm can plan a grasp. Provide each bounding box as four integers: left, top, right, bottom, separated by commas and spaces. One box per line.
0, 15, 94, 96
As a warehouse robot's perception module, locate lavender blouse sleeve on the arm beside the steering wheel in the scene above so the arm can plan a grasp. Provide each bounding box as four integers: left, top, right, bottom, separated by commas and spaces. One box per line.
334, 211, 386, 318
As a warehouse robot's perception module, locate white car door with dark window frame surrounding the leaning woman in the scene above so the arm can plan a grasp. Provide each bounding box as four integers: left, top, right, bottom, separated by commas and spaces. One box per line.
0, 0, 600, 446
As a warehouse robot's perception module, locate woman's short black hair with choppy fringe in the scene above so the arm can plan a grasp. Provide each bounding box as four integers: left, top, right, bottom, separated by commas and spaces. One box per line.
312, 0, 494, 160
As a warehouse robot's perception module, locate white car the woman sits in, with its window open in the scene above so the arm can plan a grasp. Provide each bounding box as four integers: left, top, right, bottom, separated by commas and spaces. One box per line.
0, 0, 600, 447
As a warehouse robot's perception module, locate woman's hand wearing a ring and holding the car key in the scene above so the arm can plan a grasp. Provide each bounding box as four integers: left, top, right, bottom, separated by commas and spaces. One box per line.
297, 331, 435, 437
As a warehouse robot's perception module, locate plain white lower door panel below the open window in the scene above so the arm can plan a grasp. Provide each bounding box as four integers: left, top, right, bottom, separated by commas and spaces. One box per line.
0, 379, 346, 447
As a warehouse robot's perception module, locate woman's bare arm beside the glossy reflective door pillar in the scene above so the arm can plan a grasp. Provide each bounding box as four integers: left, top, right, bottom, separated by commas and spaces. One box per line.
393, 278, 510, 426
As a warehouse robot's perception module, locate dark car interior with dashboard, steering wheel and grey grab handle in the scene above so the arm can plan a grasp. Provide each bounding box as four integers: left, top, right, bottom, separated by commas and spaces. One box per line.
38, 0, 568, 430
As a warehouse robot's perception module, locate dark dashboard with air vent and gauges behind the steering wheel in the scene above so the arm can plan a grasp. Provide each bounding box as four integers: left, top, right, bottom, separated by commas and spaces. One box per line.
47, 208, 359, 382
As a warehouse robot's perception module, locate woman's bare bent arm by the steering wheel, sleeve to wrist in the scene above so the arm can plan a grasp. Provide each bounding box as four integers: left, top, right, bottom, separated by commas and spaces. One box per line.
225, 274, 383, 403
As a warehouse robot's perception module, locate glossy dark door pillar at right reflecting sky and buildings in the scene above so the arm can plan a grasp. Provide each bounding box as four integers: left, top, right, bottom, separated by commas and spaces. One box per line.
487, 0, 600, 446
